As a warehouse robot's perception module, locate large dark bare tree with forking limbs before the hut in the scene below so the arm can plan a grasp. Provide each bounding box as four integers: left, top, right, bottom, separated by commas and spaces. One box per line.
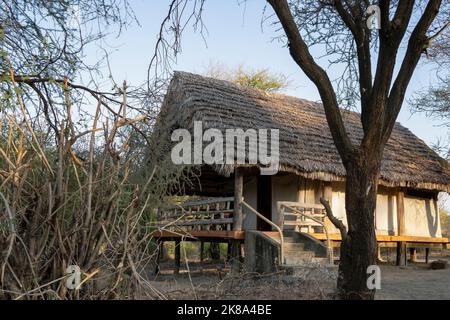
268, 0, 448, 299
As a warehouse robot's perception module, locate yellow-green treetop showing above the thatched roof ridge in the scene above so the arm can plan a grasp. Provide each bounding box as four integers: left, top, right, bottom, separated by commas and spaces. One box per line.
204, 64, 289, 92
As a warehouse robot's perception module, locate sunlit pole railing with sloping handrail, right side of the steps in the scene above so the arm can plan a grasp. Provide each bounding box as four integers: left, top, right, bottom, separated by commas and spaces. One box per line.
277, 201, 334, 264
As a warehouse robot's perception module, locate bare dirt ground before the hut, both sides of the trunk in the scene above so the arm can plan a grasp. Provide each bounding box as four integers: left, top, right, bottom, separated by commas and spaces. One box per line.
151, 251, 450, 300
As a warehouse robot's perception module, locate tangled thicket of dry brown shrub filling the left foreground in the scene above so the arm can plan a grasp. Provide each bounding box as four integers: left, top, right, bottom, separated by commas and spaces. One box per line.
0, 70, 186, 299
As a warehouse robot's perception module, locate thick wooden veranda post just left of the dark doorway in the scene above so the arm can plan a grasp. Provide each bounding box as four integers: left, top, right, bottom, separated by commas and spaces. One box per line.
231, 167, 244, 274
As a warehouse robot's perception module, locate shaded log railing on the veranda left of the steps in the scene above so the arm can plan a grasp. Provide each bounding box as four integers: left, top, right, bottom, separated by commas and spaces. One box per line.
158, 197, 234, 231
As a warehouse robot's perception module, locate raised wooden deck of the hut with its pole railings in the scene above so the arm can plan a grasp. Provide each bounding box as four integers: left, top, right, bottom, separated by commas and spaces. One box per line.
152, 197, 450, 248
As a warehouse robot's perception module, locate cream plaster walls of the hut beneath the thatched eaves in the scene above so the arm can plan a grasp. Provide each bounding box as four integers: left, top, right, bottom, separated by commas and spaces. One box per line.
243, 175, 442, 237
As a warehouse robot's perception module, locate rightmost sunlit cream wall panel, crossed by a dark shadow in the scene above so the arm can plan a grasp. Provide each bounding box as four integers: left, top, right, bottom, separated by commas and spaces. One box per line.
405, 196, 442, 237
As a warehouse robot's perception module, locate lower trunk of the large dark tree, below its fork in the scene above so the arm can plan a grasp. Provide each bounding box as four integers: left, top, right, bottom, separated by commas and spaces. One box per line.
337, 154, 380, 299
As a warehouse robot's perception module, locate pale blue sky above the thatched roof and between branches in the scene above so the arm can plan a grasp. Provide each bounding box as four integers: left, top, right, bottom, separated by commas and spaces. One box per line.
88, 0, 446, 148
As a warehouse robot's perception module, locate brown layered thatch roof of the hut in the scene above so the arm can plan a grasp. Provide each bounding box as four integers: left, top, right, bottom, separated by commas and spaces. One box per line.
156, 72, 450, 191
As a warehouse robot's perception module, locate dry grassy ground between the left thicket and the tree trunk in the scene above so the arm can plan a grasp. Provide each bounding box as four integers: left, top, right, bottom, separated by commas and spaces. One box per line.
152, 266, 337, 300
